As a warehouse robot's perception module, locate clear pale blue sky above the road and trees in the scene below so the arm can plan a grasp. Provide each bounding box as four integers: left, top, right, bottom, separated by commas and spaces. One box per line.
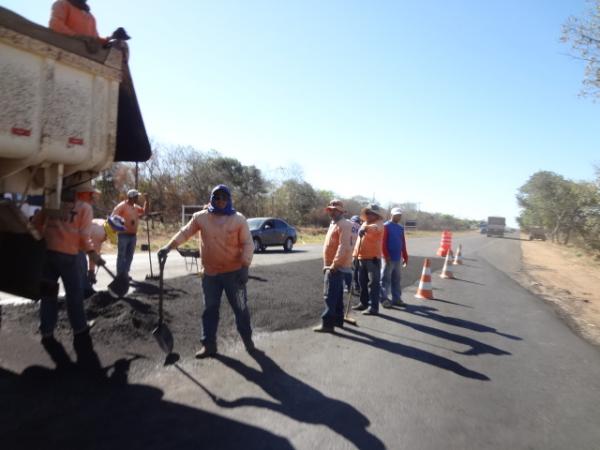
2, 0, 600, 224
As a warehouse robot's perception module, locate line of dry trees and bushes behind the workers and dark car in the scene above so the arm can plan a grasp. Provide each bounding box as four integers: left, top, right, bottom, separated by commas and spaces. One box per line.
96, 144, 478, 232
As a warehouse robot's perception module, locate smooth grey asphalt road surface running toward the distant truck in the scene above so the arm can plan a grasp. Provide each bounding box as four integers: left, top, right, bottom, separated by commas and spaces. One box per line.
0, 235, 600, 449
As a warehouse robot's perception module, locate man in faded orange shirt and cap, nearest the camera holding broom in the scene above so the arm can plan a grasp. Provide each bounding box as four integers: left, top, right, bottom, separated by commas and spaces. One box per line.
313, 200, 353, 333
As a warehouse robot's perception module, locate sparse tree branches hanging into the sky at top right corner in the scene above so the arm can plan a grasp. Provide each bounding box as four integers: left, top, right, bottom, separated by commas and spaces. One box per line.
561, 0, 600, 97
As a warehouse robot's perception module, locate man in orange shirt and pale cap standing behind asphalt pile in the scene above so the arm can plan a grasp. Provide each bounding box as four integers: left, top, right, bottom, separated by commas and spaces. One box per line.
112, 189, 150, 276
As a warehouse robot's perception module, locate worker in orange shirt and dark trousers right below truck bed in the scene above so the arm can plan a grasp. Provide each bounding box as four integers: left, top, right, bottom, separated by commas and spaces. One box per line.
33, 185, 104, 369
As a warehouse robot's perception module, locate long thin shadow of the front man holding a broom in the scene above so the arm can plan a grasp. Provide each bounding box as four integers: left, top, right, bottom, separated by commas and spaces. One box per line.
338, 327, 490, 381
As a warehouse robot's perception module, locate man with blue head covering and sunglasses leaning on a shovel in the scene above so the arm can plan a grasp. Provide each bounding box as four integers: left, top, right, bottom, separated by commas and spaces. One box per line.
158, 184, 255, 358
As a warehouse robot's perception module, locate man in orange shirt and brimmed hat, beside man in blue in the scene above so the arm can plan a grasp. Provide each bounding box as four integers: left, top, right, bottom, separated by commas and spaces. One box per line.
353, 204, 386, 315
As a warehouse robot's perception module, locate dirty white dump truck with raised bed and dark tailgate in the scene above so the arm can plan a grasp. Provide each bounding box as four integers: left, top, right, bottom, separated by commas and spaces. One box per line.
0, 7, 151, 299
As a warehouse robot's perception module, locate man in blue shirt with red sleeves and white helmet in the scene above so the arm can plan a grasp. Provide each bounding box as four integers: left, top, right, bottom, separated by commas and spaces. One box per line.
381, 208, 408, 308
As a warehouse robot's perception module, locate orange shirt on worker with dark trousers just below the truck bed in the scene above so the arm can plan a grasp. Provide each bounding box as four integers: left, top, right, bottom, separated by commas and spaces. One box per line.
33, 201, 94, 255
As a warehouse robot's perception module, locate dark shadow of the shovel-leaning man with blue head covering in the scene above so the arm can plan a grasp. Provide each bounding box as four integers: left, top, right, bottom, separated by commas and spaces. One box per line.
216, 350, 385, 450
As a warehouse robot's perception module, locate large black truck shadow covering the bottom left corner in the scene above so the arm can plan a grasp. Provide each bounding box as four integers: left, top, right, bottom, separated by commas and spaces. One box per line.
0, 346, 293, 450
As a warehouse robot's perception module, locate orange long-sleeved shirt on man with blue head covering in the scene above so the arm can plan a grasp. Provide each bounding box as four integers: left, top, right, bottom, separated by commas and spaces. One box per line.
173, 210, 254, 275
